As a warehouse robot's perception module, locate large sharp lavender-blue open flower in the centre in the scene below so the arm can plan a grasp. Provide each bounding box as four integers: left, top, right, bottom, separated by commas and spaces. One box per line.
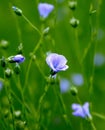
46, 53, 69, 75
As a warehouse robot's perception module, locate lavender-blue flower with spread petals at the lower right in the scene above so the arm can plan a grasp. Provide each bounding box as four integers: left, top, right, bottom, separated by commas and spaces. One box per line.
72, 102, 92, 119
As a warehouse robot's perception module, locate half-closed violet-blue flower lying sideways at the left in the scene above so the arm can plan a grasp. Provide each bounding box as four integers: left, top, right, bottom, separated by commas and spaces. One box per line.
8, 54, 25, 63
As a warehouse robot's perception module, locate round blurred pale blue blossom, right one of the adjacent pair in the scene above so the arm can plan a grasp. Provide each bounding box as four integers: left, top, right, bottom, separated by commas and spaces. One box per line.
71, 74, 84, 86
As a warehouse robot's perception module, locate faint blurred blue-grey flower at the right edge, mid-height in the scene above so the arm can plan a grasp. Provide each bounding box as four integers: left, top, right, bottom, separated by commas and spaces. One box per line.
94, 53, 105, 66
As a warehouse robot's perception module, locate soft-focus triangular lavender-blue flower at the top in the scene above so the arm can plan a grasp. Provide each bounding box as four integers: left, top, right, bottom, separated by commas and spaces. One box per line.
38, 3, 54, 18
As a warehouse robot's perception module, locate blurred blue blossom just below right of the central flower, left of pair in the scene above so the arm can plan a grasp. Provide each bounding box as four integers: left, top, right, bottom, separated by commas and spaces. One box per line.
60, 79, 70, 93
